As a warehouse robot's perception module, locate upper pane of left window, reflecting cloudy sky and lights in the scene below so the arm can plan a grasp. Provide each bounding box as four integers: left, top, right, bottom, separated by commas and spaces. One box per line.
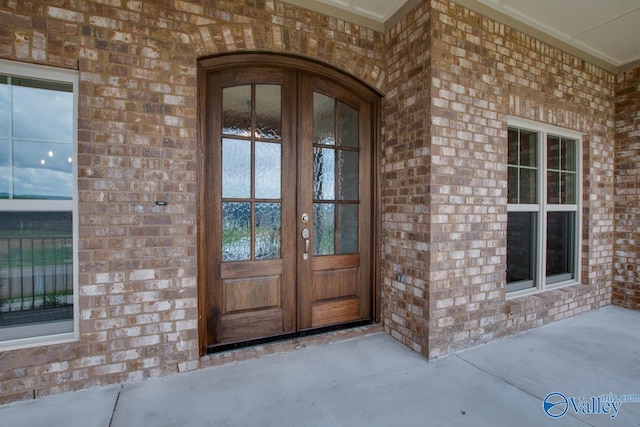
0, 76, 74, 200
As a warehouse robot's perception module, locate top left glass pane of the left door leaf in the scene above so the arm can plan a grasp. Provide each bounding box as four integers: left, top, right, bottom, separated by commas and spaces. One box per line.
222, 85, 251, 136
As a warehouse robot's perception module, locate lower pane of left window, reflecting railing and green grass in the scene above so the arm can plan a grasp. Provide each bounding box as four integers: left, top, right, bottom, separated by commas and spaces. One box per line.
0, 212, 73, 340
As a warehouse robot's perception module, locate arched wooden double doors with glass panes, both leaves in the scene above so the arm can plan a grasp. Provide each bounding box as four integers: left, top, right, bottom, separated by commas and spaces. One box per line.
199, 55, 375, 351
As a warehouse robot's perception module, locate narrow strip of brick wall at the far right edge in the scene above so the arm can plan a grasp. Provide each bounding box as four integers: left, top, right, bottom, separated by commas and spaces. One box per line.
613, 69, 640, 310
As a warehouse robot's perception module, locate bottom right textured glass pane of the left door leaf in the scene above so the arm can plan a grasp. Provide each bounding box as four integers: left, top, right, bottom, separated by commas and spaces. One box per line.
255, 203, 282, 259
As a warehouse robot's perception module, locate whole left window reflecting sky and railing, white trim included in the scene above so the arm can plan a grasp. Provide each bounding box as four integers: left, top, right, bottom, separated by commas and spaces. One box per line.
0, 61, 78, 349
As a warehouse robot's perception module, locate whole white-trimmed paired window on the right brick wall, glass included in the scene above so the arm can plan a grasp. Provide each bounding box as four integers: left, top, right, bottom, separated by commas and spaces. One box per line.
507, 119, 582, 295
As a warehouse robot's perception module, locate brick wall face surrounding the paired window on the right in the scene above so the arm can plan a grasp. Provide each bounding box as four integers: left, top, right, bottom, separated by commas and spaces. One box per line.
429, 0, 615, 356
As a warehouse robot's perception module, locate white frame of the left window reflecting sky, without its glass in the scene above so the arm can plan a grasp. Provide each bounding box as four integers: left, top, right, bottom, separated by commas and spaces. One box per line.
0, 59, 80, 352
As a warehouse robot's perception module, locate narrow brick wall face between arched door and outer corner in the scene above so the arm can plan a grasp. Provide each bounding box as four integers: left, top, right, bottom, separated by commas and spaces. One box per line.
381, 3, 431, 354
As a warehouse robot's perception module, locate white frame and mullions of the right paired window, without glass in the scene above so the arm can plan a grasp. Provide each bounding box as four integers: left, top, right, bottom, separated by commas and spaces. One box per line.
505, 117, 583, 299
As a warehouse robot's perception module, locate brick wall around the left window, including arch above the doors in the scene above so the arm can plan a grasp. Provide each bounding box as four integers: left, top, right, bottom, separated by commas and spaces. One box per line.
0, 0, 385, 403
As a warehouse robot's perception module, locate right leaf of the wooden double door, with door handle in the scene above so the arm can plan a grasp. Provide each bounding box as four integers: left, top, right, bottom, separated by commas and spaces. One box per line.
297, 75, 372, 329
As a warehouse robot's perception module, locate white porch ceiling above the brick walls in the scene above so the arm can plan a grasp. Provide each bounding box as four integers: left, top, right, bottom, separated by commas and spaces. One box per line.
308, 0, 640, 67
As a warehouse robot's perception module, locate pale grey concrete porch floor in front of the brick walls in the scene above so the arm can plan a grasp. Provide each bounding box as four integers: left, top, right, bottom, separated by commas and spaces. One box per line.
0, 306, 640, 427
